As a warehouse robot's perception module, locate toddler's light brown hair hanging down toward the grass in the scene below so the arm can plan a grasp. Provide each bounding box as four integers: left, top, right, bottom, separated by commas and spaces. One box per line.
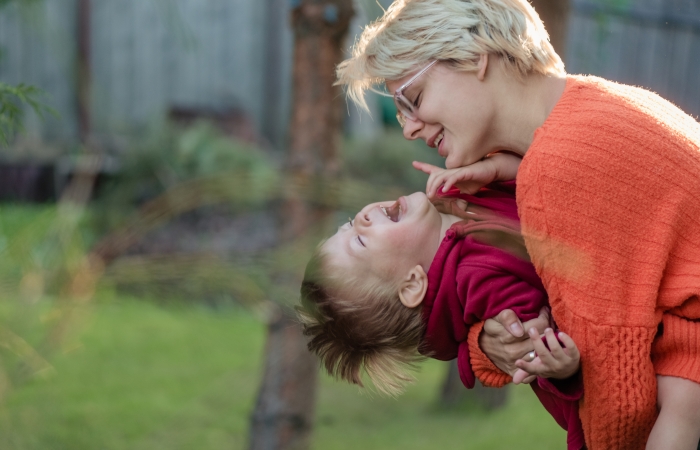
297, 245, 425, 395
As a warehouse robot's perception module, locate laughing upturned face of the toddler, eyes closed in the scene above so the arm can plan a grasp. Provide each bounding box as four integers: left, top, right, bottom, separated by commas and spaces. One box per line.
324, 192, 442, 277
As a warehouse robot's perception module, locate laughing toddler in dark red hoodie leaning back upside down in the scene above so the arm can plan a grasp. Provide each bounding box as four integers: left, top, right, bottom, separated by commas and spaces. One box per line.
298, 182, 584, 449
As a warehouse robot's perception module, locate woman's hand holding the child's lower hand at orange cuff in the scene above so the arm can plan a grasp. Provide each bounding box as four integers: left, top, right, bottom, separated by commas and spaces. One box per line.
479, 307, 550, 383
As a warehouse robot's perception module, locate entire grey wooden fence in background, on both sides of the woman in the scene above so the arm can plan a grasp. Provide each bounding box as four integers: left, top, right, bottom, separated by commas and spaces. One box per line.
0, 0, 700, 150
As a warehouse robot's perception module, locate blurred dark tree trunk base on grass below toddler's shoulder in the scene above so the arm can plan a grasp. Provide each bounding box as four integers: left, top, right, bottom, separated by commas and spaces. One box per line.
440, 359, 508, 410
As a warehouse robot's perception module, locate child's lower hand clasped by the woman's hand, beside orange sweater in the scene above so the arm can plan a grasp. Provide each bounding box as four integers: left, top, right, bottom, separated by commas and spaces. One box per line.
513, 328, 581, 384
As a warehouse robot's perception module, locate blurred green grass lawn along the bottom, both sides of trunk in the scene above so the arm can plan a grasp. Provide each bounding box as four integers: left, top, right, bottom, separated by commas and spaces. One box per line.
0, 299, 565, 450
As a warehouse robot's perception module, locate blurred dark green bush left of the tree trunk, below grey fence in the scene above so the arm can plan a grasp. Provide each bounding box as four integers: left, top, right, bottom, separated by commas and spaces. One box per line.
92, 121, 278, 234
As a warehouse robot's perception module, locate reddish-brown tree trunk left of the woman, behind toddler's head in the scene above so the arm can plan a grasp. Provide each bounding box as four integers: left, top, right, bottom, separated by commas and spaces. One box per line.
249, 0, 353, 450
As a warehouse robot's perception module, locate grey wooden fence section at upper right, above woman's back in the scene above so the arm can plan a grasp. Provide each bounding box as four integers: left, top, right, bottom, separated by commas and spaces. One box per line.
566, 0, 700, 118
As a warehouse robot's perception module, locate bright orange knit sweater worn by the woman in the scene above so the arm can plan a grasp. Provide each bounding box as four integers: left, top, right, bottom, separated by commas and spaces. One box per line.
469, 76, 700, 450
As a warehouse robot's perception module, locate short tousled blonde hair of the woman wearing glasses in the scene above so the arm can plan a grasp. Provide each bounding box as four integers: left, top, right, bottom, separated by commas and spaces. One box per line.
336, 0, 565, 109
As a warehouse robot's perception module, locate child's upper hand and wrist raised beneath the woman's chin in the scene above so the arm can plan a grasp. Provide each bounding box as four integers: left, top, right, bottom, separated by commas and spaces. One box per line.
413, 153, 522, 199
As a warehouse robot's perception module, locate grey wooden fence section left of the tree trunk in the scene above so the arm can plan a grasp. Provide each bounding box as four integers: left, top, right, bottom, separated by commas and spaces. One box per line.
0, 0, 291, 148
